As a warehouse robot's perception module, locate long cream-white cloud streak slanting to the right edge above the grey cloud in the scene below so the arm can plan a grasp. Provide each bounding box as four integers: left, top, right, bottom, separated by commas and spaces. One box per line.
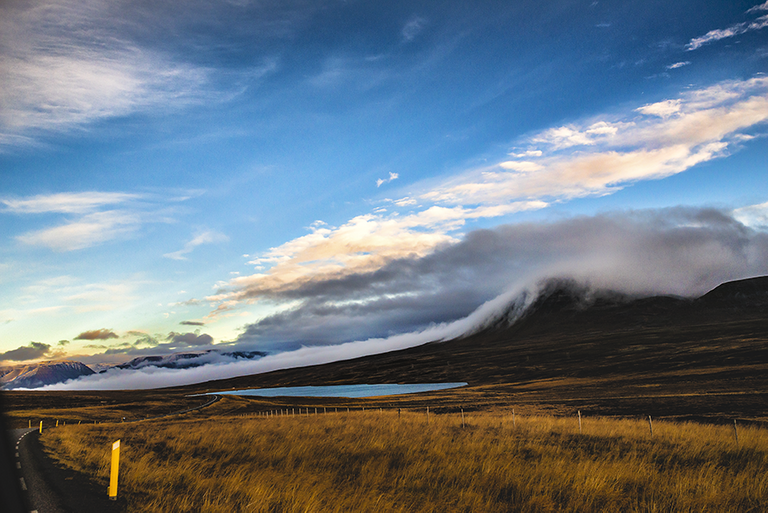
201, 77, 768, 326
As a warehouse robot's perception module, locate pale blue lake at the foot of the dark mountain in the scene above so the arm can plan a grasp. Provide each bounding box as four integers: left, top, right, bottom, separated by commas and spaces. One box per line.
208, 383, 467, 398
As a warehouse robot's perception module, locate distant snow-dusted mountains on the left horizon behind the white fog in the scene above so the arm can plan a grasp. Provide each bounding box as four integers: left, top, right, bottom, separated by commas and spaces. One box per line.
0, 349, 267, 390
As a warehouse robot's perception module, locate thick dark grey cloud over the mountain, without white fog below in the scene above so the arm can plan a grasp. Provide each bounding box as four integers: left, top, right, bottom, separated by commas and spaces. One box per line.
236, 208, 768, 350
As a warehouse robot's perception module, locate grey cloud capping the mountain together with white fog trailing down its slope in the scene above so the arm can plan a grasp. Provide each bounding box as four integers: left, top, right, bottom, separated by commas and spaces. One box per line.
46, 208, 768, 390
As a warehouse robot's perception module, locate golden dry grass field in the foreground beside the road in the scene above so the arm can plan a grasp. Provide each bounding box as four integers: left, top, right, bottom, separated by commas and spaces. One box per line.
42, 410, 768, 513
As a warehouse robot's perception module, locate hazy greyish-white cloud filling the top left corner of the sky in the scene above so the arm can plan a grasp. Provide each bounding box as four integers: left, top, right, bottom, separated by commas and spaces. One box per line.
0, 0, 210, 144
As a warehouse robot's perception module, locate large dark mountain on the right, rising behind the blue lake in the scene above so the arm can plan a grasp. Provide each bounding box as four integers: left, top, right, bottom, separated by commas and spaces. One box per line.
177, 277, 768, 420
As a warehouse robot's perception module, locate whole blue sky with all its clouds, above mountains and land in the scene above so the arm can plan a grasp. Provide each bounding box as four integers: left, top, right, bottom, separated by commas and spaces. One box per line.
0, 0, 768, 383
